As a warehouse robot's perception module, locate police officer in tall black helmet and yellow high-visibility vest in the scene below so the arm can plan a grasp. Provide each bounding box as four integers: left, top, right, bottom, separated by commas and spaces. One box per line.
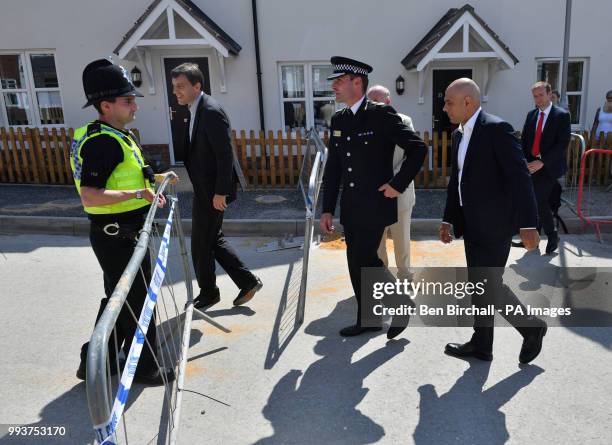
70, 59, 174, 384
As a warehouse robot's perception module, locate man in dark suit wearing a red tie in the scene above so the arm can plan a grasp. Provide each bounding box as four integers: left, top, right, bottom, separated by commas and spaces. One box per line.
521, 82, 572, 254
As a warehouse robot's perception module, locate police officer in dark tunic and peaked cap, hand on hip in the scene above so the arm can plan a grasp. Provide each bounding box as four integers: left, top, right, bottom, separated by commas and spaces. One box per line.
320, 57, 426, 338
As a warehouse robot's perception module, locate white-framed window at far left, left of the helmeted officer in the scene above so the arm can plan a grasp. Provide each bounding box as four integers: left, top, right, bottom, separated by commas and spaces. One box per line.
0, 51, 64, 127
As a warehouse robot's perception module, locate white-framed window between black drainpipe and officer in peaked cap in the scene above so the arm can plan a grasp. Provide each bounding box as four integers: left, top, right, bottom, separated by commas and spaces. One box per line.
279, 63, 337, 131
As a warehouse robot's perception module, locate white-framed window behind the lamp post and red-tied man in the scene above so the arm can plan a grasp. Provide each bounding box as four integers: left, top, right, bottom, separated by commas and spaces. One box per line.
537, 59, 586, 127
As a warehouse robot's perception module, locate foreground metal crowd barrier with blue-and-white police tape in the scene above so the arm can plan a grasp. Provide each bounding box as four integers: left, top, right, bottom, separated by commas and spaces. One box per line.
86, 177, 199, 444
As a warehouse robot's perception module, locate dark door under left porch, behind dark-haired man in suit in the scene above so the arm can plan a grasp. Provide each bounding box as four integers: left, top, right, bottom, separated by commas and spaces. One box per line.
164, 57, 210, 163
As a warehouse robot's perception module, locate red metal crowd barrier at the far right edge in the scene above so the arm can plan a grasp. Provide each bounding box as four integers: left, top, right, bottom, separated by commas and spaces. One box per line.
577, 148, 612, 242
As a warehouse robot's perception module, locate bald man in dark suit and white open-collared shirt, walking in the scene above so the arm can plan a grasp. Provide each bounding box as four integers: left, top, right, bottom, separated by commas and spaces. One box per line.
439, 78, 546, 363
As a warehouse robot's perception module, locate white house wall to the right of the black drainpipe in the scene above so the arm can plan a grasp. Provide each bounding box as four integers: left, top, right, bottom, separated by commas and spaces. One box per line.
258, 0, 612, 129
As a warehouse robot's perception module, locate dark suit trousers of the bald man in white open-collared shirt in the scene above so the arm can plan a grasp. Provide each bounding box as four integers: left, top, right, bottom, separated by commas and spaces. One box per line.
464, 238, 529, 352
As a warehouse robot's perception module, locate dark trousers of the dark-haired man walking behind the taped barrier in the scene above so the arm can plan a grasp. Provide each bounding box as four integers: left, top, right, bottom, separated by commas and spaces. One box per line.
191, 196, 257, 295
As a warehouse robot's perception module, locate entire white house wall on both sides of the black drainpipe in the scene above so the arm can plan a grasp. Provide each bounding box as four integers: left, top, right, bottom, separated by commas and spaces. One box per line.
0, 0, 612, 144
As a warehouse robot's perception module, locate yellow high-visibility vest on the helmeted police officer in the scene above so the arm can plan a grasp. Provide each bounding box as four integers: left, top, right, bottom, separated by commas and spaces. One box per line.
70, 122, 151, 215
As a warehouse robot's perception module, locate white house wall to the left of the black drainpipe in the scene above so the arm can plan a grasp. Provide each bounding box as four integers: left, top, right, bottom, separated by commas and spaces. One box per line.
0, 0, 259, 144
